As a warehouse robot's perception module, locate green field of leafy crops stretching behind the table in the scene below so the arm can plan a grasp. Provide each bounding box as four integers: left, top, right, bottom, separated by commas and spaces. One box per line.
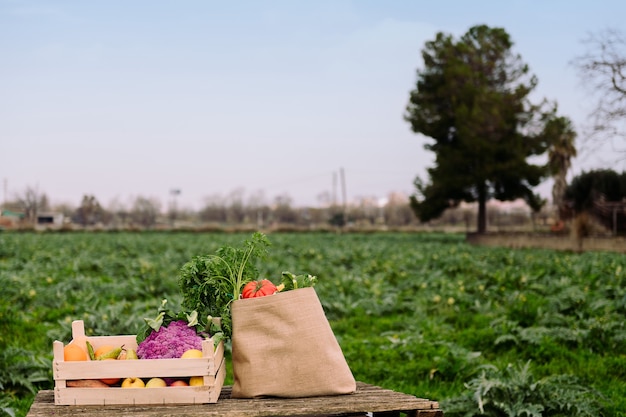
0, 232, 626, 416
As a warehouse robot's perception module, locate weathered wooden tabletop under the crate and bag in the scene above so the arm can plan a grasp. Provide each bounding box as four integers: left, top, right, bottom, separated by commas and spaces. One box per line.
27, 382, 443, 417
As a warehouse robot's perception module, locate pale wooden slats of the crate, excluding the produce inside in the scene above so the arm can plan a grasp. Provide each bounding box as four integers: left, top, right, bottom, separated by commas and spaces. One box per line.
52, 320, 226, 405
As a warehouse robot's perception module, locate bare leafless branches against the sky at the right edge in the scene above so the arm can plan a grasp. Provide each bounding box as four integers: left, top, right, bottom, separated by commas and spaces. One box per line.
573, 29, 626, 153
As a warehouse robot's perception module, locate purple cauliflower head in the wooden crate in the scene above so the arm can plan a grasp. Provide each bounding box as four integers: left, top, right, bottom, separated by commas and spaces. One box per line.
137, 320, 202, 359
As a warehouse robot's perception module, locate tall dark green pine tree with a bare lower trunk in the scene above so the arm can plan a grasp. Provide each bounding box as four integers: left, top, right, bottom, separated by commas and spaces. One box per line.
404, 25, 548, 233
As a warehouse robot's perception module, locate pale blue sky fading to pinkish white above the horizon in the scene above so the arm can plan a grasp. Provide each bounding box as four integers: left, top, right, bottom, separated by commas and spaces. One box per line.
0, 0, 626, 209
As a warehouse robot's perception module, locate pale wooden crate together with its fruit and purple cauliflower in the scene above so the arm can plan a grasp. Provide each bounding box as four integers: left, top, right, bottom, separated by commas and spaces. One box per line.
53, 312, 224, 405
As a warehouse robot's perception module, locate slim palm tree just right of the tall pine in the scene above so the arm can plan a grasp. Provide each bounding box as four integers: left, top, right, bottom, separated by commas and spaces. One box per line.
544, 117, 577, 221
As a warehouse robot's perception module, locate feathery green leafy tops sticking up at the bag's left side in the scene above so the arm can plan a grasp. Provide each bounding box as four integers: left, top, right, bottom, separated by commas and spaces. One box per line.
178, 232, 270, 339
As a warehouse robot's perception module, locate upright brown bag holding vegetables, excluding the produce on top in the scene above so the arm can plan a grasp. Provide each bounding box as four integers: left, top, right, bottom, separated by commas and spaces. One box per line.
231, 287, 356, 398
